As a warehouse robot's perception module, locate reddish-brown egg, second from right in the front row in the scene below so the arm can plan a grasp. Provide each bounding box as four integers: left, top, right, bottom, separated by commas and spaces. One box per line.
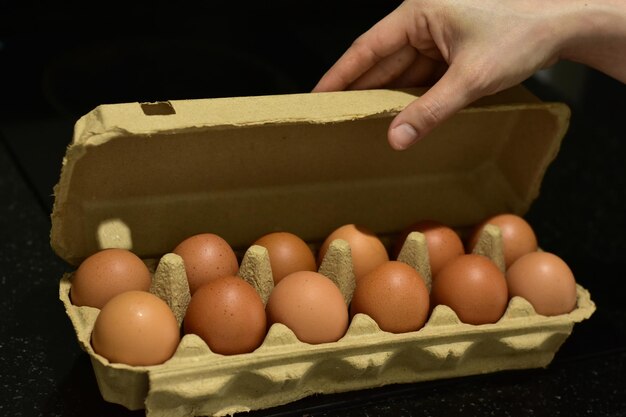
430, 254, 508, 324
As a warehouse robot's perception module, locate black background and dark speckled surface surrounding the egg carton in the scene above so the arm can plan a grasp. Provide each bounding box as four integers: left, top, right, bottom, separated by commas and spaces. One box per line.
0, 1, 626, 416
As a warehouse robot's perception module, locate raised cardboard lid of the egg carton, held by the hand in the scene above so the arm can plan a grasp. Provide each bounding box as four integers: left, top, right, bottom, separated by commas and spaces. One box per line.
51, 86, 570, 265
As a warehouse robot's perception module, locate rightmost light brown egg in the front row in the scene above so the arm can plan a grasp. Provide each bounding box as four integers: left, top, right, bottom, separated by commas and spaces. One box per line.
506, 252, 576, 316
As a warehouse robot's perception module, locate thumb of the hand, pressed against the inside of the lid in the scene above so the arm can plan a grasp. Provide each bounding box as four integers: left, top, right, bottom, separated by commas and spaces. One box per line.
387, 67, 472, 150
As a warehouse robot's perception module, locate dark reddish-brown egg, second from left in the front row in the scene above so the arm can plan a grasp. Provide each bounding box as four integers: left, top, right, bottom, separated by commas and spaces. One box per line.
183, 276, 267, 355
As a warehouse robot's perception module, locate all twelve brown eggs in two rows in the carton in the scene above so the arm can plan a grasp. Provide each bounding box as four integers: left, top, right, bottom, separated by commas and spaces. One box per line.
70, 213, 576, 365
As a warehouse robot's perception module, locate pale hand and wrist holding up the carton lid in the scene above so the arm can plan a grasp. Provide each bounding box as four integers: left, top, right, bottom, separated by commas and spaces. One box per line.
313, 0, 626, 150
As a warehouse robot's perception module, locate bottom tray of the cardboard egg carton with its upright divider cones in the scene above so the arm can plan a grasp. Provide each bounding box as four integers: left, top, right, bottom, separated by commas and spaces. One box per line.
60, 225, 595, 417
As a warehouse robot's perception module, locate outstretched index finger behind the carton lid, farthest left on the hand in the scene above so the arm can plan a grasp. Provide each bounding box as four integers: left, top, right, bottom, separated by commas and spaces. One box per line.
313, 5, 409, 92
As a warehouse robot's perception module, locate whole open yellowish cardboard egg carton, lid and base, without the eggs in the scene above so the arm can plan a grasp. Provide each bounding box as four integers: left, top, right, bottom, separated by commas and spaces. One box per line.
51, 87, 595, 416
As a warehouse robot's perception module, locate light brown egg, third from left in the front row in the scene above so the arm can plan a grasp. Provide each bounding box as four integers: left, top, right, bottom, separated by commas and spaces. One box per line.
266, 271, 349, 344
